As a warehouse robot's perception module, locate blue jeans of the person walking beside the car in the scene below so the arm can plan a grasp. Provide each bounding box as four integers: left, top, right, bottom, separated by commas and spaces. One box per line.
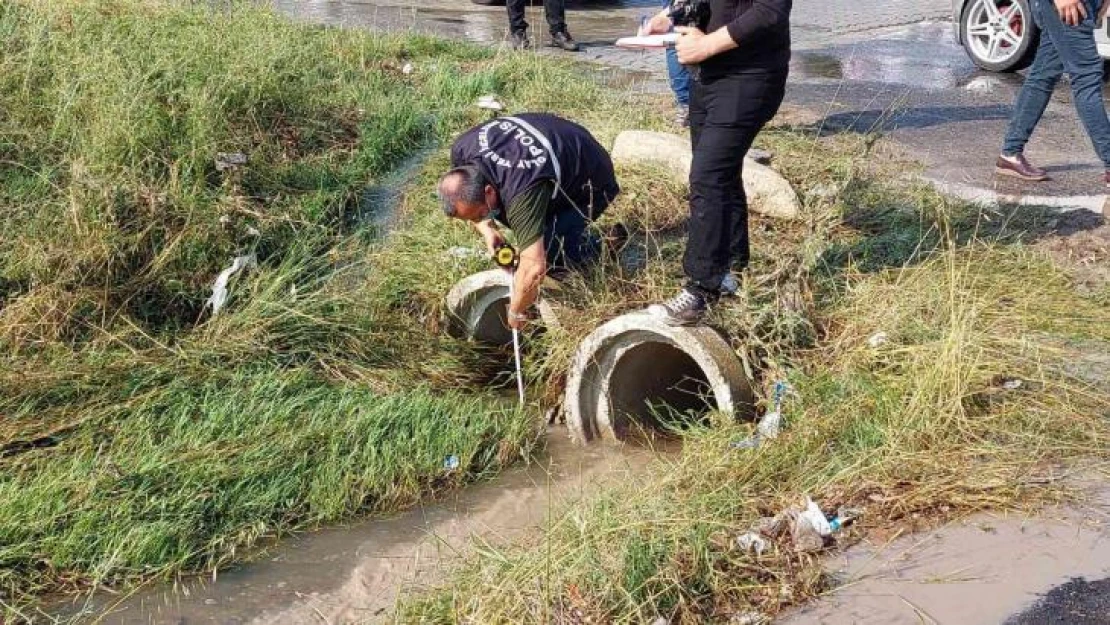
1002, 0, 1110, 170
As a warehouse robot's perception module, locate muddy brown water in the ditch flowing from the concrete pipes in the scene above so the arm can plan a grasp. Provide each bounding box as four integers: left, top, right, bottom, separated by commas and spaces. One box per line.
78, 426, 668, 624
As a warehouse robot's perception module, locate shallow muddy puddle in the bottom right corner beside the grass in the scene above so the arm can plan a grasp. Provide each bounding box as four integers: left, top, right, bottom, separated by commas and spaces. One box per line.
781, 486, 1110, 625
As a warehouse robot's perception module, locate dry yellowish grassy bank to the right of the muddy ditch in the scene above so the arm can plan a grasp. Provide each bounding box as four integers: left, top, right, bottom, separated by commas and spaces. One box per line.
397, 89, 1110, 624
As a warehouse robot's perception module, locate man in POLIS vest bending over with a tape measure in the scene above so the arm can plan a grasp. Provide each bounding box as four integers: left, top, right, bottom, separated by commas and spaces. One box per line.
438, 113, 620, 329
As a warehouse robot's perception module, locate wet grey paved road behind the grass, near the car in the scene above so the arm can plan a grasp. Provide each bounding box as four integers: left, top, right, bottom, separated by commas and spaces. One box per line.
274, 0, 1107, 212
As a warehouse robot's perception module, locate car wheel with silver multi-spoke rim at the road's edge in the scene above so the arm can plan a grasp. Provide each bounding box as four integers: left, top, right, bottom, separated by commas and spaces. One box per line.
960, 0, 1039, 72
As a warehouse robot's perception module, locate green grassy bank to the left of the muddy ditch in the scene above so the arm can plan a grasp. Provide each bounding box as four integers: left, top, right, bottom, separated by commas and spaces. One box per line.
0, 0, 657, 619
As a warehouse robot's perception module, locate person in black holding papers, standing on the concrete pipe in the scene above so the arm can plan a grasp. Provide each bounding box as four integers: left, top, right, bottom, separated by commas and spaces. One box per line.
646, 0, 791, 325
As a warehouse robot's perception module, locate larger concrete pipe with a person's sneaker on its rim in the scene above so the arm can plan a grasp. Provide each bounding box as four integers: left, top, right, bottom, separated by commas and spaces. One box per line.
565, 312, 755, 443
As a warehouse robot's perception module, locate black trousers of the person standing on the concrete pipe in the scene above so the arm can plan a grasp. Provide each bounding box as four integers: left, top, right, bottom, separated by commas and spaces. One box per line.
683, 71, 786, 292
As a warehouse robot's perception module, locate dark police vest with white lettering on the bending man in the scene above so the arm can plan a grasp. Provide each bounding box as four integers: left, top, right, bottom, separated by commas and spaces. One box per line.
451, 113, 620, 228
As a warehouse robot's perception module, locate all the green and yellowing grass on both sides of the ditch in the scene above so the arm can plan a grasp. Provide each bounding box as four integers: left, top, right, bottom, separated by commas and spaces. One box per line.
8, 0, 1110, 623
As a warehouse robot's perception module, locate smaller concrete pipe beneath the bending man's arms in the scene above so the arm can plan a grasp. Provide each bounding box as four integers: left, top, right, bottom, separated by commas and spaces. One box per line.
447, 269, 558, 345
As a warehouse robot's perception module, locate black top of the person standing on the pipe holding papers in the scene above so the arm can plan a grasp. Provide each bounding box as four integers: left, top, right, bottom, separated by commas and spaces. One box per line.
702, 0, 791, 78
